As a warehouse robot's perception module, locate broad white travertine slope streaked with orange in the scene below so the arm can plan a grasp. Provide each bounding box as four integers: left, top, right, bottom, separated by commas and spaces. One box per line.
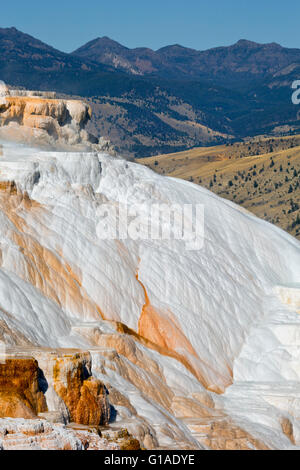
0, 142, 300, 449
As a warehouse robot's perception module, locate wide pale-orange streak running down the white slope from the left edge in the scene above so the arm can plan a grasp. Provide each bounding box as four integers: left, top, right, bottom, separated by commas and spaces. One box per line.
0, 182, 104, 319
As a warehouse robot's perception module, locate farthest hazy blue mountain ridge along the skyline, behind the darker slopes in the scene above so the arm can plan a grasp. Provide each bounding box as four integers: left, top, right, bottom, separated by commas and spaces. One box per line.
72, 37, 300, 82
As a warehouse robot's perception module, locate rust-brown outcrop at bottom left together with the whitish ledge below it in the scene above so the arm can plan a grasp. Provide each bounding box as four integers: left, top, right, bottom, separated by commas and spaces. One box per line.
0, 349, 140, 450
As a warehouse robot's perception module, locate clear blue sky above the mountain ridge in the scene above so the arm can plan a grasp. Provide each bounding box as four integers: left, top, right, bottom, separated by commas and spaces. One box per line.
0, 0, 300, 52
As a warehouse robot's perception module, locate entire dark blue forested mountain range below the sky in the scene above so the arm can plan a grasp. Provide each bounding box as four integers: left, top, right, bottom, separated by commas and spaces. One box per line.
0, 28, 300, 157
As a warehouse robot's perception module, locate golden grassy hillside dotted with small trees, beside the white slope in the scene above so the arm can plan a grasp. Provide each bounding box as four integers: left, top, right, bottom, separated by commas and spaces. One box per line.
137, 136, 300, 239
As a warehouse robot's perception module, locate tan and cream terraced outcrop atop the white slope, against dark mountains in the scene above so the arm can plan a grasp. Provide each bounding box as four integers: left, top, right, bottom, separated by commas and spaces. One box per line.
0, 83, 113, 153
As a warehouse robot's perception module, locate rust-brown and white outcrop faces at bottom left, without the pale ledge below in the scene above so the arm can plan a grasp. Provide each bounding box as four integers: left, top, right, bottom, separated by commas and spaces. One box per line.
0, 349, 110, 426
